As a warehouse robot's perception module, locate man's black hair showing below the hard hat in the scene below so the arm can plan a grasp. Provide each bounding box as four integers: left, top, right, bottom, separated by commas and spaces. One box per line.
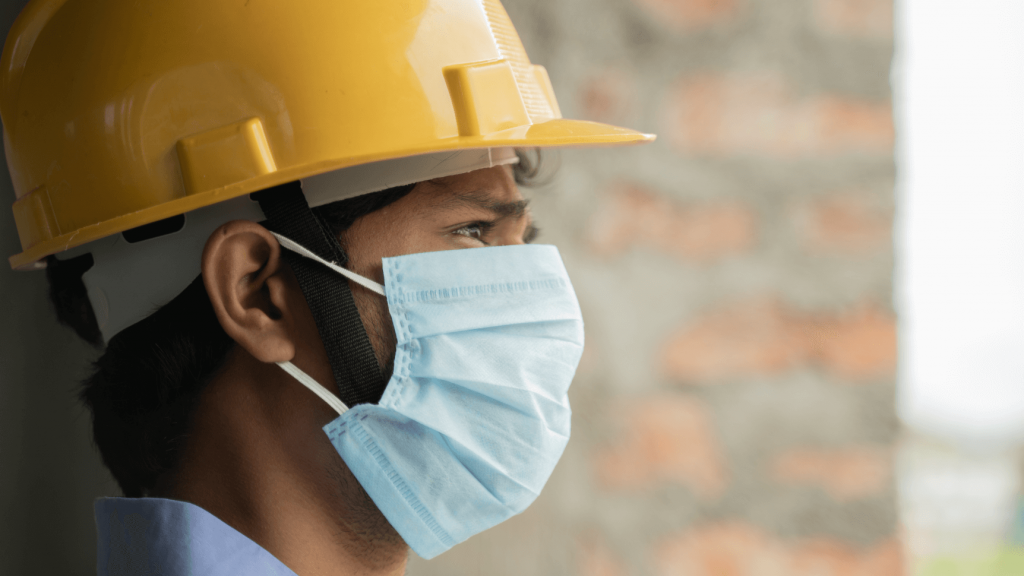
46, 149, 542, 497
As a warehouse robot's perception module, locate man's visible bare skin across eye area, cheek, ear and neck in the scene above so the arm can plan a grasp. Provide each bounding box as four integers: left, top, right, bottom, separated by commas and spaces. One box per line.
193, 161, 537, 572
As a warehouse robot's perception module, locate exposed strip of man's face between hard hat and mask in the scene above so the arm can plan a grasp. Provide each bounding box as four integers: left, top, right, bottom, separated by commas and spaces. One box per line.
340, 166, 538, 377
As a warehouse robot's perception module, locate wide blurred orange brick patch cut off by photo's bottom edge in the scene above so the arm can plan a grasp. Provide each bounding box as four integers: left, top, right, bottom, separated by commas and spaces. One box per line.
654, 522, 903, 576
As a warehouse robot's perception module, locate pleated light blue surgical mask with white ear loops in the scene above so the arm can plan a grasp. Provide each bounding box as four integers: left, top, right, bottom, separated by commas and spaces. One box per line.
268, 231, 584, 559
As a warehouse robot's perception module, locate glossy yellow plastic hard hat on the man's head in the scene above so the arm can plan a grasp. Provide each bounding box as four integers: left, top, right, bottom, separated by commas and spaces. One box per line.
0, 0, 653, 269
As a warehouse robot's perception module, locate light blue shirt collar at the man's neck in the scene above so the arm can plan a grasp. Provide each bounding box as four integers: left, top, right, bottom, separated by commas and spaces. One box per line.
94, 498, 296, 576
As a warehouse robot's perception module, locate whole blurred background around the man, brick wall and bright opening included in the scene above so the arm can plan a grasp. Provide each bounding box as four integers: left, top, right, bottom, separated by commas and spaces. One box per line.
0, 0, 1024, 576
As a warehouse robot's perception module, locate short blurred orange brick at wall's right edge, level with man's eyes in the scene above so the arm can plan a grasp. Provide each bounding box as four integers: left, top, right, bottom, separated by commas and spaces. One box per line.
797, 193, 892, 255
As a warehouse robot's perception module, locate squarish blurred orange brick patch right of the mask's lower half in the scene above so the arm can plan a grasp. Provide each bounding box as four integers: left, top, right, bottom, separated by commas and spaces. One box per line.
595, 395, 726, 498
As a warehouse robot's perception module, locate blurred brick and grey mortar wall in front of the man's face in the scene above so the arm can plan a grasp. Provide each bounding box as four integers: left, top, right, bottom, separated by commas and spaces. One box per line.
410, 0, 903, 576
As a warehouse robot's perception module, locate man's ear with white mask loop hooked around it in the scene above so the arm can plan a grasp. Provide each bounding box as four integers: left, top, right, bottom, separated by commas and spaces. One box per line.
203, 220, 294, 363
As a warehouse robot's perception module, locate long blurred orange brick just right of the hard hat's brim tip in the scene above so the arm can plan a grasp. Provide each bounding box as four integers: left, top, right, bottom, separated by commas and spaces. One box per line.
665, 73, 894, 158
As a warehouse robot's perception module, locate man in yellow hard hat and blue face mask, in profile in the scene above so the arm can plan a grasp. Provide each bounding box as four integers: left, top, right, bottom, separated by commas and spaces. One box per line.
0, 0, 652, 576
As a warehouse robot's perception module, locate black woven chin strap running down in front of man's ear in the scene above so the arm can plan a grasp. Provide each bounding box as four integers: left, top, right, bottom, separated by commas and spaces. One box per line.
253, 181, 385, 408
